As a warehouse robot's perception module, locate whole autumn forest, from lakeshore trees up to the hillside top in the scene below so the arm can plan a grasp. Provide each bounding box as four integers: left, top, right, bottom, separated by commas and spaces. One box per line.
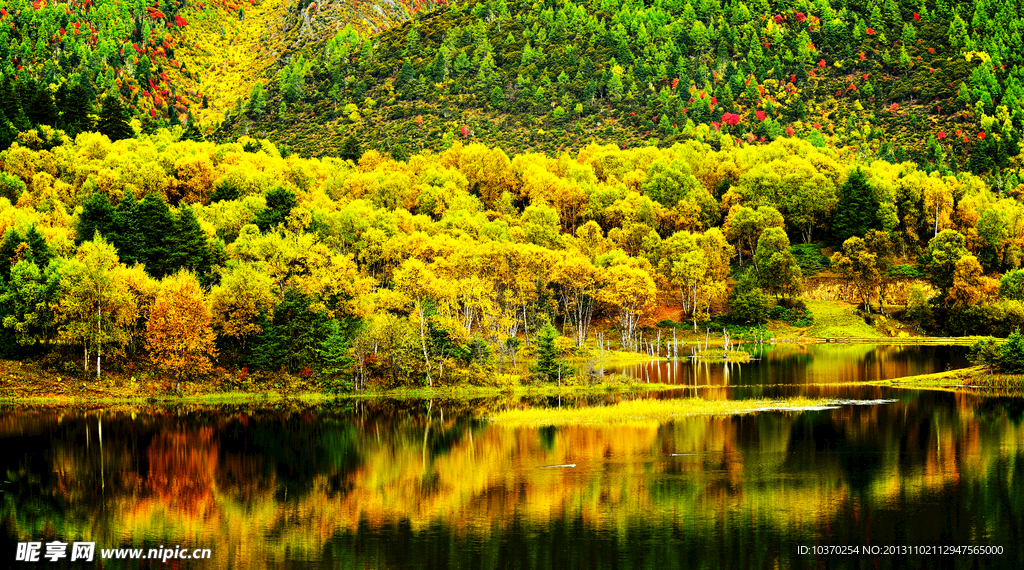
0, 0, 1024, 392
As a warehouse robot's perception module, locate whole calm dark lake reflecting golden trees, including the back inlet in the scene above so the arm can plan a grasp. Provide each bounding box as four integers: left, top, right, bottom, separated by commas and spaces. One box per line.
0, 346, 1024, 569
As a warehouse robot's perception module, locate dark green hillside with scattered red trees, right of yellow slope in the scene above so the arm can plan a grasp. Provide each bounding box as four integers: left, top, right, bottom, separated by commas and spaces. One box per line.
209, 0, 1024, 175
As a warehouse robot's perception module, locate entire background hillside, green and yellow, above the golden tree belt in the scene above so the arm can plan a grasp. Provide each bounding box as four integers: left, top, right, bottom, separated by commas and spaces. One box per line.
0, 0, 1024, 180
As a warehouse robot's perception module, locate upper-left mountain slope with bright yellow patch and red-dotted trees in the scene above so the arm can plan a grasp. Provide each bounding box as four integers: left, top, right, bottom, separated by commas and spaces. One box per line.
0, 0, 418, 143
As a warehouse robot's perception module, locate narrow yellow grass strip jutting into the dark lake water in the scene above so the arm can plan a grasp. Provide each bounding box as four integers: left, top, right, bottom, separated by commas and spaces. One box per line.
490, 397, 837, 427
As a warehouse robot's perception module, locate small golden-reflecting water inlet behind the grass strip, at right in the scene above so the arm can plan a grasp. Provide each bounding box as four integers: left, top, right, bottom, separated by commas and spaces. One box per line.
605, 344, 969, 386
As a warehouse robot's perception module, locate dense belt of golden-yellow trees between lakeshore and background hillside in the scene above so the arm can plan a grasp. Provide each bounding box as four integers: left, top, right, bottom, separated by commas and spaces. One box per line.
0, 118, 1024, 385
